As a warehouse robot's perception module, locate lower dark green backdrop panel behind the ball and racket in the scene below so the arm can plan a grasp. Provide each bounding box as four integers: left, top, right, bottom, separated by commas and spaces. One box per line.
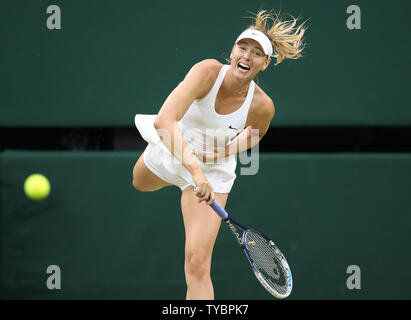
0, 151, 411, 299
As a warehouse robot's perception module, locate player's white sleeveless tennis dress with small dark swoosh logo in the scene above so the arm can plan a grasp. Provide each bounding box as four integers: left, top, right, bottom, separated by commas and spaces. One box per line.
135, 65, 255, 193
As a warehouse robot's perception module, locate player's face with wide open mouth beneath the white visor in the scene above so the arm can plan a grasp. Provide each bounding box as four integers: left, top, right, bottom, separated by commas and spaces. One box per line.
230, 39, 271, 79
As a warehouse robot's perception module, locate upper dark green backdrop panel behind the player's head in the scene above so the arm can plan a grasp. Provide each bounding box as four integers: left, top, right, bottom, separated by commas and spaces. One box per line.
0, 0, 411, 127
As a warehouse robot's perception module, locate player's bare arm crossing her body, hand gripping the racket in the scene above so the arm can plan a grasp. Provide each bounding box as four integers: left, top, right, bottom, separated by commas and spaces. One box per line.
154, 59, 221, 204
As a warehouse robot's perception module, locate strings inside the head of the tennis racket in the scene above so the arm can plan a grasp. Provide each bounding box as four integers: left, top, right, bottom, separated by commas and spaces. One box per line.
245, 231, 288, 294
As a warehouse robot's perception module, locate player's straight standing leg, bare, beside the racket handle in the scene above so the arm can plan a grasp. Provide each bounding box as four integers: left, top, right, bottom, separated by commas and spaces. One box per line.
181, 187, 228, 300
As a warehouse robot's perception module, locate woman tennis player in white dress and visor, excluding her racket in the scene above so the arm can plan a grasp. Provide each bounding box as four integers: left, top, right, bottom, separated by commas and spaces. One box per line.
133, 10, 306, 299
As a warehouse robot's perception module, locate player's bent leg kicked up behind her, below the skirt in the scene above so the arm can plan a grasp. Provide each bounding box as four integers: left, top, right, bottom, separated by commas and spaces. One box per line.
133, 153, 171, 191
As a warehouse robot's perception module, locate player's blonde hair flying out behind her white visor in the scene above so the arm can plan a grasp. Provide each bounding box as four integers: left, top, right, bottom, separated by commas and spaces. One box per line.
249, 10, 307, 65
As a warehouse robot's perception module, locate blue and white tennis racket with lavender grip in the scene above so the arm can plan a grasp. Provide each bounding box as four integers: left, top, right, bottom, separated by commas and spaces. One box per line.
197, 190, 293, 299
